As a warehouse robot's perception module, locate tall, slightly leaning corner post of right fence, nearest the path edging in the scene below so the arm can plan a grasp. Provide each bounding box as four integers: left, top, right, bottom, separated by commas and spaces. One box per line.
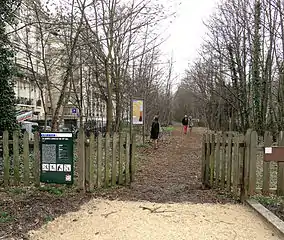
241, 129, 252, 201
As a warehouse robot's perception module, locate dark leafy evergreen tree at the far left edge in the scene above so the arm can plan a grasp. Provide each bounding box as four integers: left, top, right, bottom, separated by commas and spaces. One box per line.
0, 0, 18, 131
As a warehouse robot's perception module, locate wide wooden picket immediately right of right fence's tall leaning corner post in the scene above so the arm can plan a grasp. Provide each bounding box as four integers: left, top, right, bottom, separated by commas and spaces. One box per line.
248, 131, 258, 196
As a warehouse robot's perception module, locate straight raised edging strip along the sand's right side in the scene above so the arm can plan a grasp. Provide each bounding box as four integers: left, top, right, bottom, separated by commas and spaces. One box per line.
246, 199, 284, 237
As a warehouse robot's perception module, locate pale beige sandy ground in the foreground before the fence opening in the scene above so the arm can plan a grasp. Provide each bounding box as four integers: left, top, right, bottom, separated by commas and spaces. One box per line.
29, 199, 281, 240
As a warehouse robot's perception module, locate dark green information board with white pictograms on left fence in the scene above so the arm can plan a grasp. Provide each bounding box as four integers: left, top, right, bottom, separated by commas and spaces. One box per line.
40, 132, 74, 184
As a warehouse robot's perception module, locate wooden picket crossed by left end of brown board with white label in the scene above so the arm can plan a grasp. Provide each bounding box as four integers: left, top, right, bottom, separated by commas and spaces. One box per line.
262, 131, 272, 195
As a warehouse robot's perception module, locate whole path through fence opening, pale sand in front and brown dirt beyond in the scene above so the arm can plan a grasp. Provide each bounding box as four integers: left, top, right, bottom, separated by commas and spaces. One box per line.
30, 128, 281, 240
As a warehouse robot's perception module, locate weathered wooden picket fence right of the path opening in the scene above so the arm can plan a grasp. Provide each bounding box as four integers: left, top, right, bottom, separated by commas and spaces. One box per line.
201, 129, 284, 201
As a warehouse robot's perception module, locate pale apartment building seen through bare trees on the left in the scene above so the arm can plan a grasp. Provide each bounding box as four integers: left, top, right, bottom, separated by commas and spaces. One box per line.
11, 0, 108, 126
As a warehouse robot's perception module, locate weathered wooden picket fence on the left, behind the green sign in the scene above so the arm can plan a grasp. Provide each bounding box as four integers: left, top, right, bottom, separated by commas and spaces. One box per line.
0, 130, 136, 191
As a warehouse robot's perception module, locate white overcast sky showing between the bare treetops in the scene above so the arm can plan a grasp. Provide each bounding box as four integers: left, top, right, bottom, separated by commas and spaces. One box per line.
161, 0, 218, 82
